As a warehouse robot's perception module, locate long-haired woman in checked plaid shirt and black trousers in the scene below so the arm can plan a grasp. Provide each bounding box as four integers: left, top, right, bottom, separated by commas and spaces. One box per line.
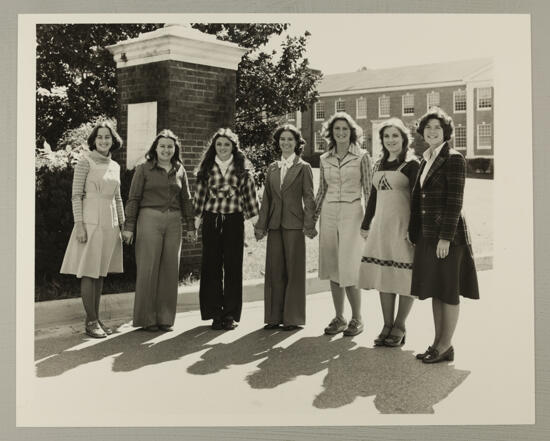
193, 129, 259, 330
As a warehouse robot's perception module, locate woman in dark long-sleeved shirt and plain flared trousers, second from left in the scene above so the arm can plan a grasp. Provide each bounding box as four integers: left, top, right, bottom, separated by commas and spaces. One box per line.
123, 130, 196, 331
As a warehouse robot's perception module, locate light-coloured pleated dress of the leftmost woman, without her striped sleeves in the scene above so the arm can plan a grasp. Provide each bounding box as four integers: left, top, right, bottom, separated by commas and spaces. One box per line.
60, 156, 123, 279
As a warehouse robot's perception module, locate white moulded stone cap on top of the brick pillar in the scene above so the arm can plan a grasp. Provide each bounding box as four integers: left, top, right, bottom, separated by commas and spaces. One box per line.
107, 23, 247, 70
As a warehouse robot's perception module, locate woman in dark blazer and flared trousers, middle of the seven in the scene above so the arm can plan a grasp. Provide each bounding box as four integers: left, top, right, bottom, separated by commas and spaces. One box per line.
254, 124, 317, 331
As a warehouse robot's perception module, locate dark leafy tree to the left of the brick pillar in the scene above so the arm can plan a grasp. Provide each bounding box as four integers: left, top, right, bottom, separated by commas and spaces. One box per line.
36, 24, 162, 148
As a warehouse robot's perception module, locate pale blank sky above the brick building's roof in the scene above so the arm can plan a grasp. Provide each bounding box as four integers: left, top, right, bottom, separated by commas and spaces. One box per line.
268, 14, 506, 74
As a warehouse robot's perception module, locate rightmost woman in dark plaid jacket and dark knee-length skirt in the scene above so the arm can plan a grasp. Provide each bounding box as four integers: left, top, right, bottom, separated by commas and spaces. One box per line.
409, 107, 479, 363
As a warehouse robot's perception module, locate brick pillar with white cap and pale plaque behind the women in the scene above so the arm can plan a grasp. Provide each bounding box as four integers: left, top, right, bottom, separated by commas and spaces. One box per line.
108, 24, 246, 270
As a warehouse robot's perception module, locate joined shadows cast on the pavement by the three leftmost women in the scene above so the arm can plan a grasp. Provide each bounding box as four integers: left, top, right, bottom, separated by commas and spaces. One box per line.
36, 326, 218, 377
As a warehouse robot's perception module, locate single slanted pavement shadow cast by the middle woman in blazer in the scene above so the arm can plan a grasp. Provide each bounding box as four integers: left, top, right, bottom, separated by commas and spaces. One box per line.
187, 329, 300, 375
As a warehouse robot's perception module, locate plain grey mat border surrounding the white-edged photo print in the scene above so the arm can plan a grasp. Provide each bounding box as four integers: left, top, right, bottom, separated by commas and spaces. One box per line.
0, 0, 550, 441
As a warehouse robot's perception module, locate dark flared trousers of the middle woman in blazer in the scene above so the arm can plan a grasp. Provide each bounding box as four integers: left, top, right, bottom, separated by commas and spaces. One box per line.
264, 229, 306, 325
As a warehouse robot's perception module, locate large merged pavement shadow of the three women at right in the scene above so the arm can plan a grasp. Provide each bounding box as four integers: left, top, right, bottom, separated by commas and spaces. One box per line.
247, 336, 470, 414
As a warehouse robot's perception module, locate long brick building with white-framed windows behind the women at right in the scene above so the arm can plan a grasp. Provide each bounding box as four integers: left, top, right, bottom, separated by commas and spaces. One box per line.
286, 58, 494, 166
